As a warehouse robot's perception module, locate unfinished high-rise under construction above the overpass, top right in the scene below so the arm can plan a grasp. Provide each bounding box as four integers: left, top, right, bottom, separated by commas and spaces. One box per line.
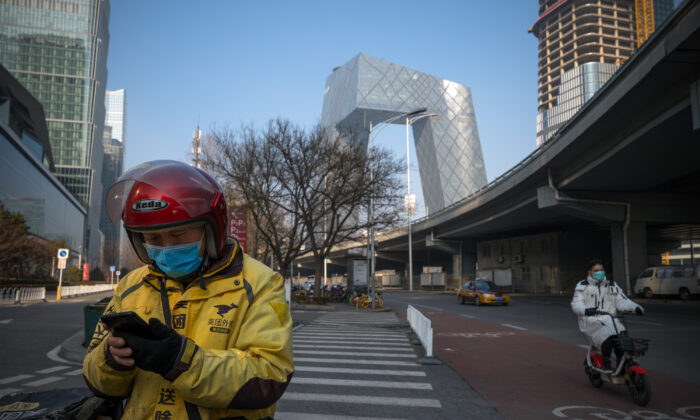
528, 0, 673, 146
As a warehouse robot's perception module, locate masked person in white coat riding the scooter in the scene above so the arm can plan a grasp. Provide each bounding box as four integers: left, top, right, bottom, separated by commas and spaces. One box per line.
571, 259, 644, 370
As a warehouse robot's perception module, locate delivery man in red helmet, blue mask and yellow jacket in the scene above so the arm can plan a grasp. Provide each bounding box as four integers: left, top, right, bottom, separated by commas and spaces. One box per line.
83, 161, 294, 420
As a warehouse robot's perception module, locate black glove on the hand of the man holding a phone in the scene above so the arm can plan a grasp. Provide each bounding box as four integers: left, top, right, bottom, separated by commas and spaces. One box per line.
114, 318, 184, 375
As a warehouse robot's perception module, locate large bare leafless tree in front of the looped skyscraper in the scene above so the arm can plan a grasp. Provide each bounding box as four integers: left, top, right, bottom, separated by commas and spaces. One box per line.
209, 119, 402, 296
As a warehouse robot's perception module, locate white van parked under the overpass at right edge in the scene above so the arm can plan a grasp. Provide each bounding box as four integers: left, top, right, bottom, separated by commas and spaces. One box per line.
634, 265, 700, 300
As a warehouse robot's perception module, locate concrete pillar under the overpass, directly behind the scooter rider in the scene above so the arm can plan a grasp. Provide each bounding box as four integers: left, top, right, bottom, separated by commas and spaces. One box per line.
610, 222, 647, 295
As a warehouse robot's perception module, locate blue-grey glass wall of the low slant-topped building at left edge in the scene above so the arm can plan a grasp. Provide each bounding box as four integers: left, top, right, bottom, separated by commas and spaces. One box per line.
0, 124, 86, 251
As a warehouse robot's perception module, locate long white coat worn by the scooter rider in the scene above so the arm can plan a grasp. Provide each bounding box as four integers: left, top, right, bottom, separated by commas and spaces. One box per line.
571, 276, 644, 348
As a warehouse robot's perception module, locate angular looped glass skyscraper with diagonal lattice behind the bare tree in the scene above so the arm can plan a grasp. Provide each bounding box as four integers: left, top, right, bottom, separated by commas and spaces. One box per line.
321, 54, 487, 213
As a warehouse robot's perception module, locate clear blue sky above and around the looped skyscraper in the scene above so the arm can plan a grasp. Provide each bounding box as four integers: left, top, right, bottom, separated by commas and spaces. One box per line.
107, 0, 537, 220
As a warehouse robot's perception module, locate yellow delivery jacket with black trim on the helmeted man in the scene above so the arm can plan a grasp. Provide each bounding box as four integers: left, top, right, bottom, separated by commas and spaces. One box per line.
83, 242, 294, 420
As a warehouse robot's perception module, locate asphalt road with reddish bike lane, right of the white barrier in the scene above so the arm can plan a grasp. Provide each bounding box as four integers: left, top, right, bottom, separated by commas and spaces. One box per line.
383, 292, 700, 419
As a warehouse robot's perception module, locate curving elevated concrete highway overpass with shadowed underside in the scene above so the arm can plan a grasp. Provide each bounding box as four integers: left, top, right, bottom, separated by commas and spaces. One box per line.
298, 0, 700, 293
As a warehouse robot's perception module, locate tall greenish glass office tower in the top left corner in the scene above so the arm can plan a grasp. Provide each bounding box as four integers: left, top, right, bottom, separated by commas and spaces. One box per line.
0, 0, 110, 266
